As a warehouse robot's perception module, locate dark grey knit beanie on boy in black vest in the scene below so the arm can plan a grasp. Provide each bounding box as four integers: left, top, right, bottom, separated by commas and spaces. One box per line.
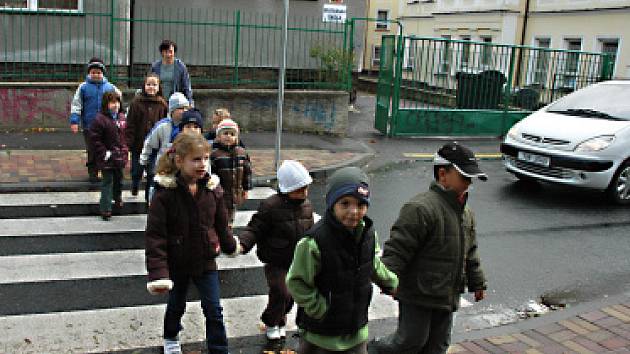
326, 167, 370, 209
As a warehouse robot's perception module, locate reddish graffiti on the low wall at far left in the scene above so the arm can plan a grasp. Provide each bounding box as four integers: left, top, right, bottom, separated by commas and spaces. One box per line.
0, 88, 72, 127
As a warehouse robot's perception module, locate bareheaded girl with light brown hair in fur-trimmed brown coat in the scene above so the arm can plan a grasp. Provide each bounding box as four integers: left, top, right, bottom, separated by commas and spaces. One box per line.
145, 134, 241, 353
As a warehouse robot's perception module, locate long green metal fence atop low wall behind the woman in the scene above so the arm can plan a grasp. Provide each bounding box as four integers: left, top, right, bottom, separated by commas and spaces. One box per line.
0, 0, 354, 90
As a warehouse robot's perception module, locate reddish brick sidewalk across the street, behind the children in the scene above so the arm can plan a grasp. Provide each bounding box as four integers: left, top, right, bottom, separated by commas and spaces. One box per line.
0, 149, 362, 183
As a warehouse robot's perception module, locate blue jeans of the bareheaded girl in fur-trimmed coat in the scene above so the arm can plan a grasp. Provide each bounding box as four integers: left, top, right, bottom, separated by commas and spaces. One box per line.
164, 270, 228, 354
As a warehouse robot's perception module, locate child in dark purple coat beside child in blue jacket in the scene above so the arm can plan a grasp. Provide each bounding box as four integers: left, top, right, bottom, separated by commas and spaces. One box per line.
90, 91, 128, 220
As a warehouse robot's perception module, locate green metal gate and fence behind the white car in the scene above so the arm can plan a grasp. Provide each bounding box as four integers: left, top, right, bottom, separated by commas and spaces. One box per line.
376, 36, 615, 136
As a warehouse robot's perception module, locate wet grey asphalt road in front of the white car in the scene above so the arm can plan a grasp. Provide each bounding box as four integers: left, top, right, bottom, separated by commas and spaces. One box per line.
311, 160, 630, 335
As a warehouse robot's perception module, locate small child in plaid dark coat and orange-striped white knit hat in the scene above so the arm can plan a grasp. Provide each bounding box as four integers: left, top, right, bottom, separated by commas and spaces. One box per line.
210, 119, 252, 226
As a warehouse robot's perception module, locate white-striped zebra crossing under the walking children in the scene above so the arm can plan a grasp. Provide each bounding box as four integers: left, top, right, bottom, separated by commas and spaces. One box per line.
0, 188, 397, 353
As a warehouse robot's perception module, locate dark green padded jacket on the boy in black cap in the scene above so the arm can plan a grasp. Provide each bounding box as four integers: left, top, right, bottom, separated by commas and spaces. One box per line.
382, 182, 486, 311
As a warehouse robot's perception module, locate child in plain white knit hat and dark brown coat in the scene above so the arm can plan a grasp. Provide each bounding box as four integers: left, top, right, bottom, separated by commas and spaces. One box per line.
239, 160, 313, 340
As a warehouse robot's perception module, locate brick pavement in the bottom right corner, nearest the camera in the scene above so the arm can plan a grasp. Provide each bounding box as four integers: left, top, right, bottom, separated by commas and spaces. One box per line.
448, 300, 630, 354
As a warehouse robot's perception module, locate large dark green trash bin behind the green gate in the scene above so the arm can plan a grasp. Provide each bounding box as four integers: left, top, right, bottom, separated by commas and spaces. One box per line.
455, 70, 506, 109
